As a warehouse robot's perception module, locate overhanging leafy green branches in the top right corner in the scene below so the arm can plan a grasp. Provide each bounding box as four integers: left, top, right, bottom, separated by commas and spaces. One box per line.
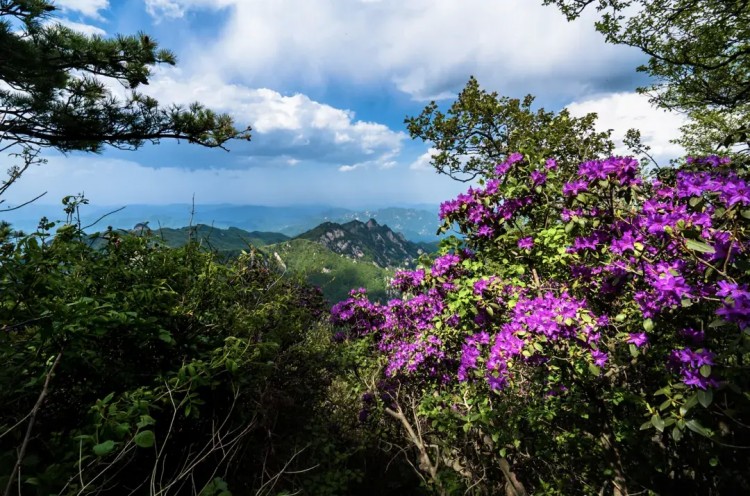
544, 0, 750, 152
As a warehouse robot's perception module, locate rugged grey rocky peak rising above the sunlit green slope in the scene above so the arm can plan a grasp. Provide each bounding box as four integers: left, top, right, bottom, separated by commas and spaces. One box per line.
296, 219, 424, 268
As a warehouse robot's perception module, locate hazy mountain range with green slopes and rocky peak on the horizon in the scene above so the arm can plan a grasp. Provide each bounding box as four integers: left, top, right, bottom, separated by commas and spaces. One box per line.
0, 204, 446, 302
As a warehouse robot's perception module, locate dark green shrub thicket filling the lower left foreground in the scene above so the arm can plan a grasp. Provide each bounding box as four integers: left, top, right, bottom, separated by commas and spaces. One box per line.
0, 214, 333, 494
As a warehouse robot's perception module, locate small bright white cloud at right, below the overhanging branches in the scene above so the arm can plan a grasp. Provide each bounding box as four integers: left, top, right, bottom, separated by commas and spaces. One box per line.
567, 93, 687, 160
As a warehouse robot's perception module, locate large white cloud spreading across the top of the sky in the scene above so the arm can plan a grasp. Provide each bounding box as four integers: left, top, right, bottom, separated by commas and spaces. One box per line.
148, 0, 641, 100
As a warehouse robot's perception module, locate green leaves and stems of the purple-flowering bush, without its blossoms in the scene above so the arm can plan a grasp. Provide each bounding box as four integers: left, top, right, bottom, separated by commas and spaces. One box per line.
339, 151, 750, 495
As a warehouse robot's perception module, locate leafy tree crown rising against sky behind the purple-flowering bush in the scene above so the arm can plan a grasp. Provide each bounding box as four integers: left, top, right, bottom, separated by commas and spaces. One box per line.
405, 77, 614, 181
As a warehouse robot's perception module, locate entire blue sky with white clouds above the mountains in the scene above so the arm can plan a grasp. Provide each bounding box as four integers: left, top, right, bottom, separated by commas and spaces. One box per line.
6, 0, 683, 208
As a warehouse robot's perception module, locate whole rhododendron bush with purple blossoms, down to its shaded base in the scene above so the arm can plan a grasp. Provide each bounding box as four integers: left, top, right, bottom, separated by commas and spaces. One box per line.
332, 153, 750, 494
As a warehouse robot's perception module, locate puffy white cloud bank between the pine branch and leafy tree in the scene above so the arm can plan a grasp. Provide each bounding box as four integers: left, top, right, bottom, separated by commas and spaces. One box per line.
144, 69, 406, 168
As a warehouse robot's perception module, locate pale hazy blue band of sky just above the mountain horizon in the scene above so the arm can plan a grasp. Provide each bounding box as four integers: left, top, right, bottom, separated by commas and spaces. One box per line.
2, 154, 466, 210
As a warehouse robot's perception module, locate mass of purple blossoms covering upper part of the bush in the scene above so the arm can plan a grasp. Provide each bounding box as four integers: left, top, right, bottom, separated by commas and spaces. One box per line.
333, 154, 750, 404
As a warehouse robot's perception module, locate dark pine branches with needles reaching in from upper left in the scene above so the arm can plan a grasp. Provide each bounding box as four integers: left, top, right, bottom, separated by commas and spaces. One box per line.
0, 0, 250, 202
